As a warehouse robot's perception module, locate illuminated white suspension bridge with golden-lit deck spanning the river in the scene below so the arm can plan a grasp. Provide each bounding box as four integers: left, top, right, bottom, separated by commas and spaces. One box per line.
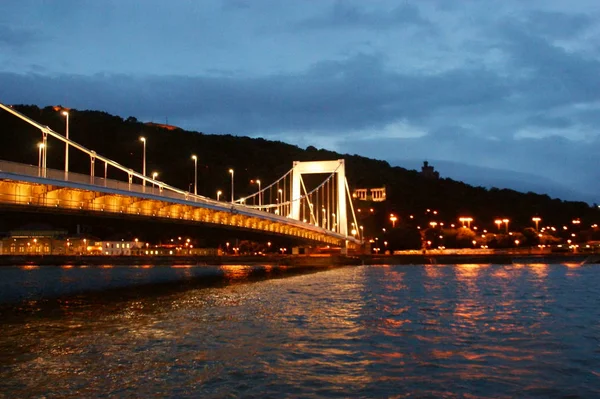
0, 103, 363, 248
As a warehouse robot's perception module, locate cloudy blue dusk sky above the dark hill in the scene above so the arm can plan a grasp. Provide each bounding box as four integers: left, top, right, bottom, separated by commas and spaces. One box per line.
0, 0, 600, 202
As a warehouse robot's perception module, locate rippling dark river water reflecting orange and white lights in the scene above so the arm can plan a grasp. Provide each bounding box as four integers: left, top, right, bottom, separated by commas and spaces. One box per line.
0, 264, 600, 398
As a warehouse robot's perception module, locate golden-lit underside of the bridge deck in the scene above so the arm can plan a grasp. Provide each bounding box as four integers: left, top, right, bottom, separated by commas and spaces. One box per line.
0, 180, 352, 245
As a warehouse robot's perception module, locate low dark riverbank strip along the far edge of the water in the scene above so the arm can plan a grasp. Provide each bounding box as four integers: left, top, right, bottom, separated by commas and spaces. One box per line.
0, 253, 600, 266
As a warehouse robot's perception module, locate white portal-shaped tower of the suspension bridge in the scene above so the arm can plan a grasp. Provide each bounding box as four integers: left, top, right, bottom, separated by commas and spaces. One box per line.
291, 159, 348, 236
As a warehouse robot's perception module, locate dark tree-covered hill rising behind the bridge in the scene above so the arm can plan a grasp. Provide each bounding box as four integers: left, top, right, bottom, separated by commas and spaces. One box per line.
0, 106, 600, 239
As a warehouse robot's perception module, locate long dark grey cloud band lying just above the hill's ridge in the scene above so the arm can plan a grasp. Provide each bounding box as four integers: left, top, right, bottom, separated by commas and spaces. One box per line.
0, 55, 508, 135
